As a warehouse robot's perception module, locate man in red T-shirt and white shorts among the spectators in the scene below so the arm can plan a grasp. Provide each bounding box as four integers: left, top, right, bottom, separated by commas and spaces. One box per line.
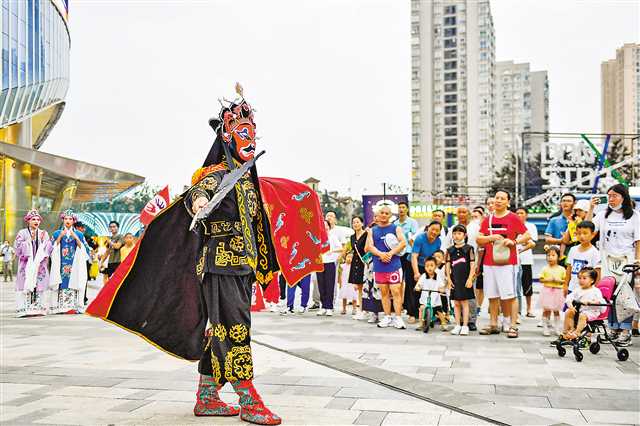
476, 190, 531, 338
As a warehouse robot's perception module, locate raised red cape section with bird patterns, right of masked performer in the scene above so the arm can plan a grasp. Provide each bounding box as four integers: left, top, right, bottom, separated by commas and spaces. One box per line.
260, 177, 329, 286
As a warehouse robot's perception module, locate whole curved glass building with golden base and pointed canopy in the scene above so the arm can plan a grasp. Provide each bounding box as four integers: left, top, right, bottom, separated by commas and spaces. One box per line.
0, 0, 144, 241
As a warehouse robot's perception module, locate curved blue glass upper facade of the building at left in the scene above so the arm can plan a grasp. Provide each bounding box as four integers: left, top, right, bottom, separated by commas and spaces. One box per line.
0, 0, 71, 128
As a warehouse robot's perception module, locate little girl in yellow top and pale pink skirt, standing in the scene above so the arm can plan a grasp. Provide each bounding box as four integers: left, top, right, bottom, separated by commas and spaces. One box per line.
540, 246, 566, 336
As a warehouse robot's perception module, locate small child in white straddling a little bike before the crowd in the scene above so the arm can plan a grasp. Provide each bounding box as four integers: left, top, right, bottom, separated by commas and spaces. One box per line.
414, 257, 447, 331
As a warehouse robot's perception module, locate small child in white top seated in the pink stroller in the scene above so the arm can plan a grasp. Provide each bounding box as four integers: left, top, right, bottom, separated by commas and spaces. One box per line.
562, 267, 607, 340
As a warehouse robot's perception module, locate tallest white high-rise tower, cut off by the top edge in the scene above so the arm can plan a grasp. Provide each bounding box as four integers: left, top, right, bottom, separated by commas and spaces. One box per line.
411, 0, 496, 199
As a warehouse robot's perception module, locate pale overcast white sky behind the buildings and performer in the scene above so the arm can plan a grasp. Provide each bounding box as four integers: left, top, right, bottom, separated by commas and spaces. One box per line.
43, 0, 640, 195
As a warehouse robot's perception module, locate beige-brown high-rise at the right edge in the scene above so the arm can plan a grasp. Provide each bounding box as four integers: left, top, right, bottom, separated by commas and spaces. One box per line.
600, 43, 640, 134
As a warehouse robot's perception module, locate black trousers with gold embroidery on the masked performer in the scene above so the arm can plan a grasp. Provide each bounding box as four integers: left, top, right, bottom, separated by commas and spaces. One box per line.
198, 274, 254, 385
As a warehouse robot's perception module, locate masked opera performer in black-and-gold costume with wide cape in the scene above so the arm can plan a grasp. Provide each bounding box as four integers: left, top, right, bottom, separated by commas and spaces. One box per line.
87, 85, 327, 425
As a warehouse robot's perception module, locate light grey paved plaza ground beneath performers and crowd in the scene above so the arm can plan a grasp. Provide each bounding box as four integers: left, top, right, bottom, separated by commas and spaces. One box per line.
0, 283, 640, 425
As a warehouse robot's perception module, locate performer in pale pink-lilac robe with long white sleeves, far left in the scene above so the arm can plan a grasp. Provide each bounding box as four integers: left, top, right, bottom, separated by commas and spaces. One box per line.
14, 210, 51, 317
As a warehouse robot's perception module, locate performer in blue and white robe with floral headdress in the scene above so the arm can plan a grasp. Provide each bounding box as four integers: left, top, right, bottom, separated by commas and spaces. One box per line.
49, 210, 89, 314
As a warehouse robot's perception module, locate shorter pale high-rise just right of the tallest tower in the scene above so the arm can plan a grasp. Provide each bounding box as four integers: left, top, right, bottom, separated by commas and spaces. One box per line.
494, 61, 549, 170
